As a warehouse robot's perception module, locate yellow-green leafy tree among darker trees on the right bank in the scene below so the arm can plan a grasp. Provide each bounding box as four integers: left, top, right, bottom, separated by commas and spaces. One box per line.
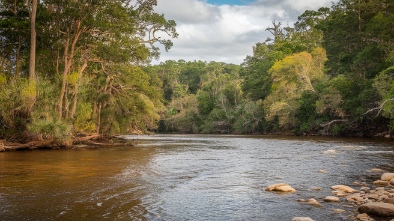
264, 48, 326, 125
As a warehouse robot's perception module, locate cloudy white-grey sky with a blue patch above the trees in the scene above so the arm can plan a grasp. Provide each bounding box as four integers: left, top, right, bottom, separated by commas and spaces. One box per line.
152, 0, 333, 64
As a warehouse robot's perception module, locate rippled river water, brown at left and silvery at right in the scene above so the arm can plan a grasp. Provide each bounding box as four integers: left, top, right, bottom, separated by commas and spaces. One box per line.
0, 135, 394, 221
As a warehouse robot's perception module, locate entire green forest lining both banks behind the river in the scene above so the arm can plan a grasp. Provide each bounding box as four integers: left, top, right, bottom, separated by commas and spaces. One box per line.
0, 0, 394, 146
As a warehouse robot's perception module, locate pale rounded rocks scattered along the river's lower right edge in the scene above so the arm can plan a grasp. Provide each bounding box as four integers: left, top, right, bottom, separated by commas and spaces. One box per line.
266, 174, 394, 221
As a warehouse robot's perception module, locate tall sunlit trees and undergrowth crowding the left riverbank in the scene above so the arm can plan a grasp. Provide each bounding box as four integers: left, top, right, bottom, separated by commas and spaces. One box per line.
0, 0, 177, 144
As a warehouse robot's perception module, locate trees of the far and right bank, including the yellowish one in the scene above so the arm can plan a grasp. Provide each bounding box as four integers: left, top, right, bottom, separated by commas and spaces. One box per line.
150, 0, 394, 136
